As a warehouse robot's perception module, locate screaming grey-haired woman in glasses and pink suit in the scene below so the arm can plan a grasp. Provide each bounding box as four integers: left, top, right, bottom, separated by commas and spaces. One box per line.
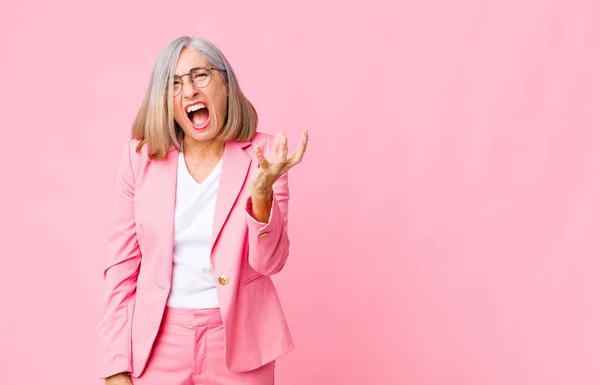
100, 37, 308, 385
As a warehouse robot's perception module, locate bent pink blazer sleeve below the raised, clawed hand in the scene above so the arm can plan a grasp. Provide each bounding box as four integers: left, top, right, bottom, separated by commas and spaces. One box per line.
246, 136, 290, 275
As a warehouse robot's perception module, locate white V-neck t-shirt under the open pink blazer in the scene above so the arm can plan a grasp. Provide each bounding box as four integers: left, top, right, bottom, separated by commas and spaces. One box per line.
167, 152, 222, 309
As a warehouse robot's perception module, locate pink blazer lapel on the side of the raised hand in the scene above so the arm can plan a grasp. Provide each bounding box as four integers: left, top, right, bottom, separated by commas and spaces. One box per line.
212, 141, 251, 247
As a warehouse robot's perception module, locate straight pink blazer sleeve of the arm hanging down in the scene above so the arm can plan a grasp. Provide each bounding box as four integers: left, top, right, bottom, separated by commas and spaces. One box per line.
100, 143, 141, 378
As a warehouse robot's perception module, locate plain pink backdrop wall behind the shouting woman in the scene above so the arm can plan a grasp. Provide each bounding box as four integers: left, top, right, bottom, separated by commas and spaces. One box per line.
0, 0, 600, 385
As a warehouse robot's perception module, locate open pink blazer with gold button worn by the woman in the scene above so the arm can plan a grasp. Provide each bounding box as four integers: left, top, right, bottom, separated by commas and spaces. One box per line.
100, 133, 294, 378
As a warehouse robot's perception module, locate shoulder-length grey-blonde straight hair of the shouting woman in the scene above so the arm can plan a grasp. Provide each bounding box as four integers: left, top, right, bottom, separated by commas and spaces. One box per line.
131, 36, 258, 160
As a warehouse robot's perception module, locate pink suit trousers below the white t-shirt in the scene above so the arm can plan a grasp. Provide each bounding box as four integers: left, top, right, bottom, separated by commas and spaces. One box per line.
131, 307, 275, 385
